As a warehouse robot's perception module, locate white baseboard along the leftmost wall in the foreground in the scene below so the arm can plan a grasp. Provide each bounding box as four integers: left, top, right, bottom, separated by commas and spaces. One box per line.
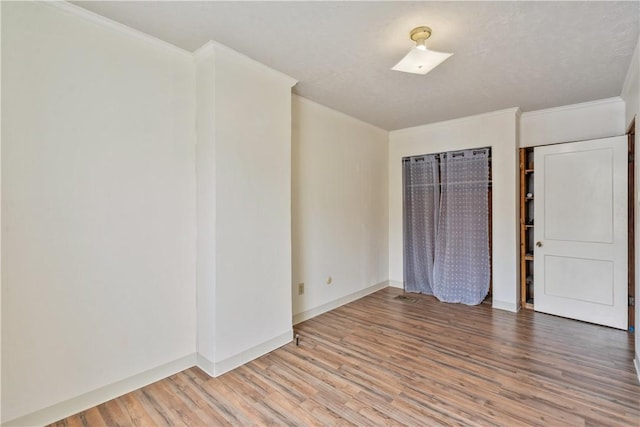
2, 353, 196, 426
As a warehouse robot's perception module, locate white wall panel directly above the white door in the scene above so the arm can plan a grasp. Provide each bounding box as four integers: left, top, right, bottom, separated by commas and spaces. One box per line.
520, 97, 626, 147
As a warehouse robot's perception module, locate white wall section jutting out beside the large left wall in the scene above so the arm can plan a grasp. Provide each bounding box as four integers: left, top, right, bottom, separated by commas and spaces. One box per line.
196, 42, 295, 375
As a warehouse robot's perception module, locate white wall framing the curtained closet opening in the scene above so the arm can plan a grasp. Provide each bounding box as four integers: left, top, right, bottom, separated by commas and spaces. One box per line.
389, 108, 520, 311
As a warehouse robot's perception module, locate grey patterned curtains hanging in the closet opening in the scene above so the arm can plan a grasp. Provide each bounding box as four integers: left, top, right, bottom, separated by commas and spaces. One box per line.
403, 149, 490, 305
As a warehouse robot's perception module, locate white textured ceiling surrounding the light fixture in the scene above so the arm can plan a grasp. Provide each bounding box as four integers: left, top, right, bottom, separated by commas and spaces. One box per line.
74, 1, 640, 130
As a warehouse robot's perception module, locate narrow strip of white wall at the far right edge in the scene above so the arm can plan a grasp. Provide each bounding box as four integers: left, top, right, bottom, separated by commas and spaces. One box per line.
621, 38, 640, 380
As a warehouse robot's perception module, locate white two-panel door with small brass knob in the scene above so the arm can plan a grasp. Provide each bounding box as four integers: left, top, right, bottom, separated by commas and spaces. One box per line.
534, 136, 628, 329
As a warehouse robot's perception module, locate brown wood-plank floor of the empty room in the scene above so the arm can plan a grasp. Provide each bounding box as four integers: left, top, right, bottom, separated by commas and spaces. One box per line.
53, 288, 640, 426
